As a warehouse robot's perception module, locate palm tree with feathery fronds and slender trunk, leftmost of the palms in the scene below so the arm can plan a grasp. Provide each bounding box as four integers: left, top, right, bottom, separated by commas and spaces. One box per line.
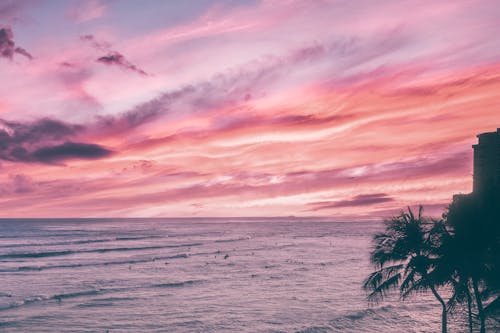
363, 206, 447, 333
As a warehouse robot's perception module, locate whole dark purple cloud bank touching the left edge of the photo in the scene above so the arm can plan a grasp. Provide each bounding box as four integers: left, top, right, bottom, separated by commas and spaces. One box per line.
0, 119, 111, 163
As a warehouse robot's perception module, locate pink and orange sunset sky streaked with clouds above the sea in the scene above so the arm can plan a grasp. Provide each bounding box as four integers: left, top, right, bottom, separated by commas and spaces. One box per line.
0, 0, 500, 221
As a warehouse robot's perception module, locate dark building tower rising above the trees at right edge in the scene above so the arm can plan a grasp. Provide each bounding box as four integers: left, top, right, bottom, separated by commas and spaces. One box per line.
472, 128, 500, 194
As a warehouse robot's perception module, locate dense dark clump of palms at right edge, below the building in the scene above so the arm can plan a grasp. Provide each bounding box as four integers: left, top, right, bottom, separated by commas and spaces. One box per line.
431, 192, 500, 333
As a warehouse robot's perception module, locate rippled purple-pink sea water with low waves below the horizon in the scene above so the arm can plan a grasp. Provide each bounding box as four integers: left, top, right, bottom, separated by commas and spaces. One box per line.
0, 219, 496, 333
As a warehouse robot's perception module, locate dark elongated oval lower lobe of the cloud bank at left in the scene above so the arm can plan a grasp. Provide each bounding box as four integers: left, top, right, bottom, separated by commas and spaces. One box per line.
31, 142, 112, 163
